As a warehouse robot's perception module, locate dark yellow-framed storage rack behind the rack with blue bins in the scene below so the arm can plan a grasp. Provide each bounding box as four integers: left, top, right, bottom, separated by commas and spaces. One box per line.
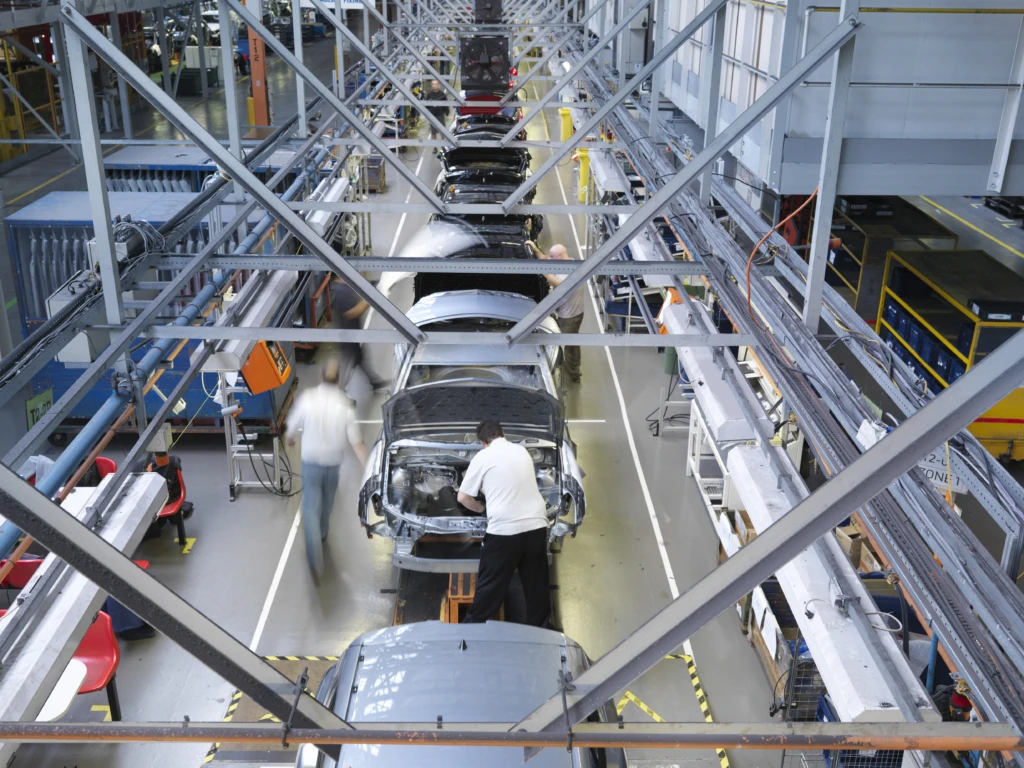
825, 198, 959, 324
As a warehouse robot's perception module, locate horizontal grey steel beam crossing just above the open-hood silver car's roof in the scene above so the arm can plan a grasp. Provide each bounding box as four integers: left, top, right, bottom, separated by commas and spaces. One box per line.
136, 326, 754, 347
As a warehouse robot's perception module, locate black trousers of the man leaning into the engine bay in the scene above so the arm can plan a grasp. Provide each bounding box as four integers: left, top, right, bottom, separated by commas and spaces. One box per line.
466, 526, 551, 627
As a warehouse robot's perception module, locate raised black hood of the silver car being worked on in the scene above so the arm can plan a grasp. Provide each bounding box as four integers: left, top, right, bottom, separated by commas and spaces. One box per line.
383, 379, 565, 444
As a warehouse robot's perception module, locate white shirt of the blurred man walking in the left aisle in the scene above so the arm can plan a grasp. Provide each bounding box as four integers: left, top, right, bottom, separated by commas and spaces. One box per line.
288, 383, 362, 467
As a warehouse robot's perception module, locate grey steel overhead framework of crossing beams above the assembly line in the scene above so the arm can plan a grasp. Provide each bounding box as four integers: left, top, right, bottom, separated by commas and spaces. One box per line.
0, 0, 1024, 755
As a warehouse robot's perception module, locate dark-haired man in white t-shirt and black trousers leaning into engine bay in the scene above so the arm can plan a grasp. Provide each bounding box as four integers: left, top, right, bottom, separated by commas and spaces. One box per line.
458, 419, 551, 627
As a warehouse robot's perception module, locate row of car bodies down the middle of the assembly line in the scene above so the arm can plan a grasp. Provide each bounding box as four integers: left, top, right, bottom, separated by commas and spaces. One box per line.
296, 79, 610, 768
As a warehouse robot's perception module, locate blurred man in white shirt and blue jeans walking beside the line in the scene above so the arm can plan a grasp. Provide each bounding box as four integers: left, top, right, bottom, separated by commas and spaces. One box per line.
286, 359, 367, 583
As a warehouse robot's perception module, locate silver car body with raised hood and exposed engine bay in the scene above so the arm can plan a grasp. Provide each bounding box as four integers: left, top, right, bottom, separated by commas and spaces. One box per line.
358, 291, 586, 572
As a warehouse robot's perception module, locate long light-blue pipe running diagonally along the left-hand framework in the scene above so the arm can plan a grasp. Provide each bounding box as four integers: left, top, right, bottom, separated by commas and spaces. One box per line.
0, 150, 329, 557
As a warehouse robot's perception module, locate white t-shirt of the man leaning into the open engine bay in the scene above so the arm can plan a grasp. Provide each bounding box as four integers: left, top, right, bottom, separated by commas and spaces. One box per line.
459, 437, 548, 536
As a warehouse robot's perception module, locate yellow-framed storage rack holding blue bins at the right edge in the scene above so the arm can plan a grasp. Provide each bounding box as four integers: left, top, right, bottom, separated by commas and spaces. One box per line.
877, 251, 1024, 461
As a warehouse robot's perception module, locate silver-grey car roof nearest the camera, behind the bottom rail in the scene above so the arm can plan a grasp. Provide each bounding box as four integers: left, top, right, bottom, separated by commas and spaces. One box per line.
335, 622, 583, 768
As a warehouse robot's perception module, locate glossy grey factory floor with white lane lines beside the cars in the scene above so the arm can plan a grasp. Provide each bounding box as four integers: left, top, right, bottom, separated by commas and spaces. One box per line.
4, 43, 779, 768
